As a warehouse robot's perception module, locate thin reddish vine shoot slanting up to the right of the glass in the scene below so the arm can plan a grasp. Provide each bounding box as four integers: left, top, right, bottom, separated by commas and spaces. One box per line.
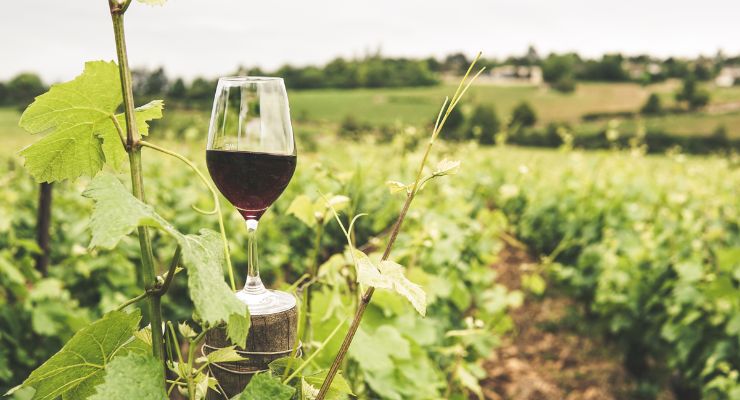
316, 53, 484, 400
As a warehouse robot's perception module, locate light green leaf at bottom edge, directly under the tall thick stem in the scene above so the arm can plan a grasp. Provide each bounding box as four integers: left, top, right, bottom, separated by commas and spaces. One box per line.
89, 353, 167, 400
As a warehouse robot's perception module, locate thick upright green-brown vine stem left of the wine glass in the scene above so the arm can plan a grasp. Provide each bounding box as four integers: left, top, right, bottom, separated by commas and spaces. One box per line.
108, 0, 165, 370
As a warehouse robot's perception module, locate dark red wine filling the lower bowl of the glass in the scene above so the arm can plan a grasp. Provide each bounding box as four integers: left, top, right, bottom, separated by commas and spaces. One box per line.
206, 150, 296, 220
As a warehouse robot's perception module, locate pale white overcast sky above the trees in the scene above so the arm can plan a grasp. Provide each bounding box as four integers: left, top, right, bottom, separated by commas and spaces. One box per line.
0, 0, 740, 81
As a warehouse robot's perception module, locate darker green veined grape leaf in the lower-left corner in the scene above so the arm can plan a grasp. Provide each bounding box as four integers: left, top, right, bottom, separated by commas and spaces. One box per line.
23, 311, 140, 400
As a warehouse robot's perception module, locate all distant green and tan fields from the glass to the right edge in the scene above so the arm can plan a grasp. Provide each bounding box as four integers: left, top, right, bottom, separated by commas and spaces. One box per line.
290, 82, 740, 137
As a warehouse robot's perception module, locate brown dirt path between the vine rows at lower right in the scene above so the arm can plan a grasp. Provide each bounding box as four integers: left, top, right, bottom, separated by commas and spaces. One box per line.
482, 247, 672, 400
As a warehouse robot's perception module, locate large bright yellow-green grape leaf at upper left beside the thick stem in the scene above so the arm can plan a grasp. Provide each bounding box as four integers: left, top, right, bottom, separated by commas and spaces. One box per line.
19, 61, 163, 182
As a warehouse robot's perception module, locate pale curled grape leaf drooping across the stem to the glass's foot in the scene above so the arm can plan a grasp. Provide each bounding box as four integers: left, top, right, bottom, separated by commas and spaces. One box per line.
83, 175, 250, 347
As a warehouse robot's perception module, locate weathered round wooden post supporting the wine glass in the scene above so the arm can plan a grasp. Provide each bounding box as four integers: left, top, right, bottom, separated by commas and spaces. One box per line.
202, 306, 298, 400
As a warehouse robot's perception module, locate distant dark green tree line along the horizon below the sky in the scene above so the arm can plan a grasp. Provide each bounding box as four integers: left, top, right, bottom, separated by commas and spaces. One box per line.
0, 46, 740, 108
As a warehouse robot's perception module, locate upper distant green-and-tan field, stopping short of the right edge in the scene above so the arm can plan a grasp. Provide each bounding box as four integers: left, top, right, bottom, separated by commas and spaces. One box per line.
290, 83, 674, 124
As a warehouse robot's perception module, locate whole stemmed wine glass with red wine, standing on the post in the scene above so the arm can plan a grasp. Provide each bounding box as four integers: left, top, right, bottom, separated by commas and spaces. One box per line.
206, 76, 296, 315
